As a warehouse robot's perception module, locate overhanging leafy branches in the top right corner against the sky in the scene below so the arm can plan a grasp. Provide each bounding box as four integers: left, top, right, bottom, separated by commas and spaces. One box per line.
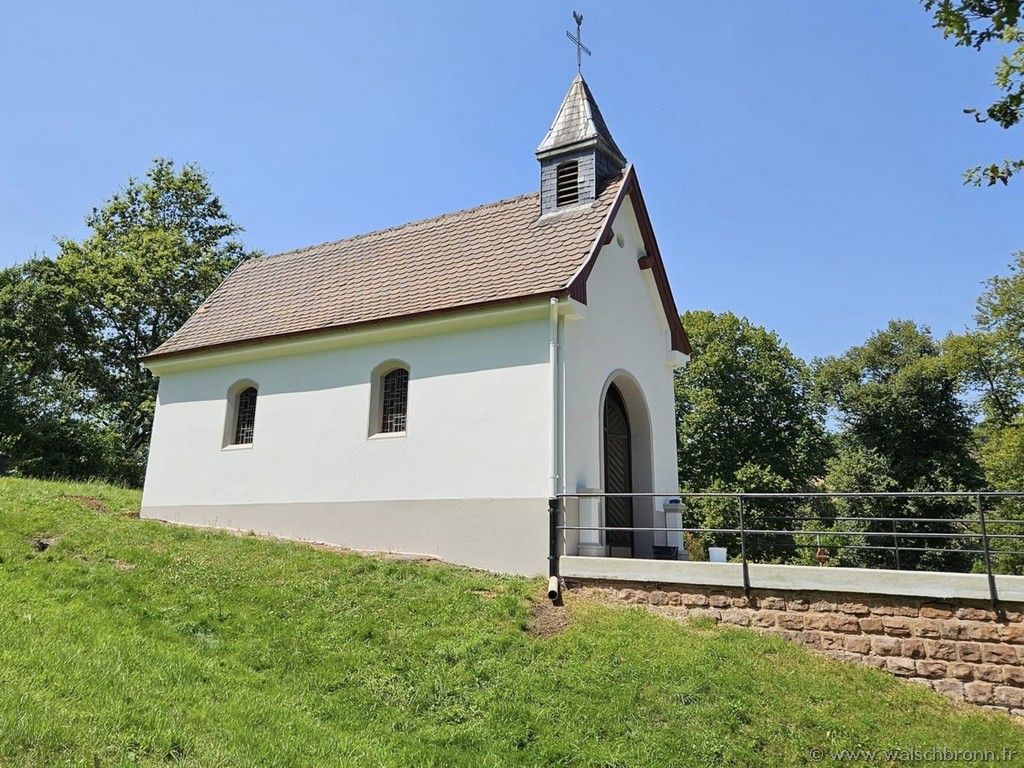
922, 0, 1024, 186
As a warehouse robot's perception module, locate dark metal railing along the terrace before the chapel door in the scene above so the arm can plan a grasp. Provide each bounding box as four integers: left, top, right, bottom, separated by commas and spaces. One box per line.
548, 490, 1024, 609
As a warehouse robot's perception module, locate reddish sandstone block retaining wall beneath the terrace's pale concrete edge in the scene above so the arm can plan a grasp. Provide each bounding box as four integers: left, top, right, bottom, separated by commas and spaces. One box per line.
566, 579, 1024, 715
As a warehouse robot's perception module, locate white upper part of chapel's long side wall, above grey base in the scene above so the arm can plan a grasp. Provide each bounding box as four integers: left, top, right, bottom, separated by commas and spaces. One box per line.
142, 316, 551, 512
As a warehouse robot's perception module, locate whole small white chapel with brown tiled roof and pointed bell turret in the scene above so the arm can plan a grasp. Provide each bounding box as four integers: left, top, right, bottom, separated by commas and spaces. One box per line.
141, 75, 690, 574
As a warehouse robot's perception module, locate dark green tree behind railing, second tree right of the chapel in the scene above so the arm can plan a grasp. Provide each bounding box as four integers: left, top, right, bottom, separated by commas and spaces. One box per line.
814, 321, 983, 569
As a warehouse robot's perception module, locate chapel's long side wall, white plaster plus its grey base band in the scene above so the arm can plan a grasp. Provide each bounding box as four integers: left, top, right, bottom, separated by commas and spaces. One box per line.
142, 313, 551, 573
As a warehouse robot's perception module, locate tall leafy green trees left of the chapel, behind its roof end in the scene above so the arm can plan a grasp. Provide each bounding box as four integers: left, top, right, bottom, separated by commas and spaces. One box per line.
0, 160, 249, 484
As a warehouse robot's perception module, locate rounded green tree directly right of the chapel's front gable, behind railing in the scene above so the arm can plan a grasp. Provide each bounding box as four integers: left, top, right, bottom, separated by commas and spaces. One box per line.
676, 311, 826, 558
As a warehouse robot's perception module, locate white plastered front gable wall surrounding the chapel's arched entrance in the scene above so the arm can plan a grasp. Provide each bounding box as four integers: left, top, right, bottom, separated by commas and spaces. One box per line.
561, 192, 679, 557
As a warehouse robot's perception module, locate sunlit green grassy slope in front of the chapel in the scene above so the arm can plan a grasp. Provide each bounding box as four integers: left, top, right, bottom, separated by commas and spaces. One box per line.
0, 479, 1024, 766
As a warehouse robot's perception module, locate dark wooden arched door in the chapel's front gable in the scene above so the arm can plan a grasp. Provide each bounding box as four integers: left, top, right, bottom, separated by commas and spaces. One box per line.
604, 384, 633, 557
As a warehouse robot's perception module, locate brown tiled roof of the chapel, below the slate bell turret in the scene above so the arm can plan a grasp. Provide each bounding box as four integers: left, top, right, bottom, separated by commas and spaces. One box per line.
147, 174, 622, 359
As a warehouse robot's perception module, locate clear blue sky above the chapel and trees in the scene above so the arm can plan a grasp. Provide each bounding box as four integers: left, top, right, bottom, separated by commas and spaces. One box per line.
0, 0, 1024, 358
